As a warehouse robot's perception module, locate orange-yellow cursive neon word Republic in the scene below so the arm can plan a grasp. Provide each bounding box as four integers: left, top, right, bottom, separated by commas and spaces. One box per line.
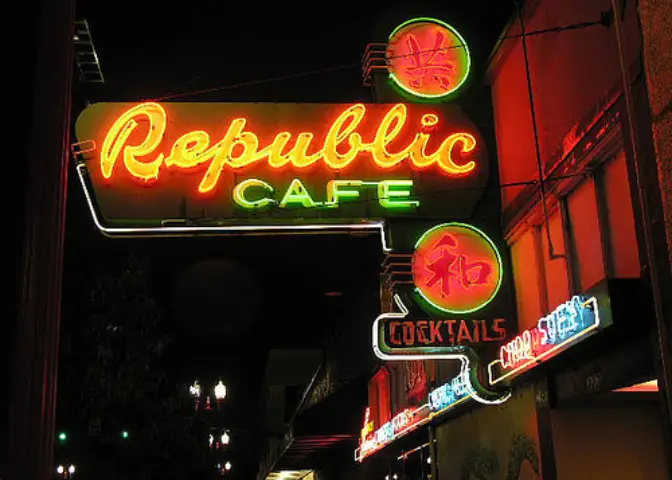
100, 102, 476, 193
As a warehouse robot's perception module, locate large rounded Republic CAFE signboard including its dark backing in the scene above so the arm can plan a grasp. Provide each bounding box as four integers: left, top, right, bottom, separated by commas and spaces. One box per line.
73, 102, 488, 234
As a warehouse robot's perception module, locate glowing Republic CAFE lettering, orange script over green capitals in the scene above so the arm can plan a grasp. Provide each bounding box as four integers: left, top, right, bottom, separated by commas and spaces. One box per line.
99, 102, 477, 209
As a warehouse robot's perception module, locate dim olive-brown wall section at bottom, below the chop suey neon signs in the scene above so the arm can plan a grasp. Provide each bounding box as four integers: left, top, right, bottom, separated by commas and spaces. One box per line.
435, 388, 540, 480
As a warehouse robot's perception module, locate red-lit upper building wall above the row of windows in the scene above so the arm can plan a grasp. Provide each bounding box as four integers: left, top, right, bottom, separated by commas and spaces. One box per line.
490, 0, 639, 214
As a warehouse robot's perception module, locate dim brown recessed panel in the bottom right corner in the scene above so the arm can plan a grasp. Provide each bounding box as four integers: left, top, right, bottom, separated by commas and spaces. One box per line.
551, 402, 669, 480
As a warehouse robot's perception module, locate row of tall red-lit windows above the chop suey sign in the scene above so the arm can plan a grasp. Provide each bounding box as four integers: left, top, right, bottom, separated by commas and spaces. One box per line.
511, 147, 640, 338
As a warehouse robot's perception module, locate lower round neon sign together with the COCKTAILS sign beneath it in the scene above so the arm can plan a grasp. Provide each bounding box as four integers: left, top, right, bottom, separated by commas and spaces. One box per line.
373, 222, 506, 360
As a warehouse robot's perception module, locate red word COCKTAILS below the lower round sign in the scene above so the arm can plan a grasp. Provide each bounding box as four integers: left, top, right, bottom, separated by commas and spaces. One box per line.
381, 318, 506, 349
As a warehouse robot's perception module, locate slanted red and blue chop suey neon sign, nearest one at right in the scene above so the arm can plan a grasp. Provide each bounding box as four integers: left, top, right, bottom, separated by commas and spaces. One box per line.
488, 295, 600, 384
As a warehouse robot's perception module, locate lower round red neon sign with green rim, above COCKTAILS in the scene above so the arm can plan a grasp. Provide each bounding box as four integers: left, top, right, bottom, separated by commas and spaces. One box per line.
411, 222, 502, 314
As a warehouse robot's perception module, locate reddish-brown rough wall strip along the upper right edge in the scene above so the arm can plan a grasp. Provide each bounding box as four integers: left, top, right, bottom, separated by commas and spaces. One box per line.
639, 0, 672, 266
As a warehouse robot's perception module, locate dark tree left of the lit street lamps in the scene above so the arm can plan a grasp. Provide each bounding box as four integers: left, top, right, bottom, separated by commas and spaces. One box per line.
80, 255, 208, 480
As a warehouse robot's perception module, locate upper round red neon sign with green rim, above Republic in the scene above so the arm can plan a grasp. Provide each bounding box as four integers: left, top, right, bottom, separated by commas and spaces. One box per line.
385, 18, 471, 99
